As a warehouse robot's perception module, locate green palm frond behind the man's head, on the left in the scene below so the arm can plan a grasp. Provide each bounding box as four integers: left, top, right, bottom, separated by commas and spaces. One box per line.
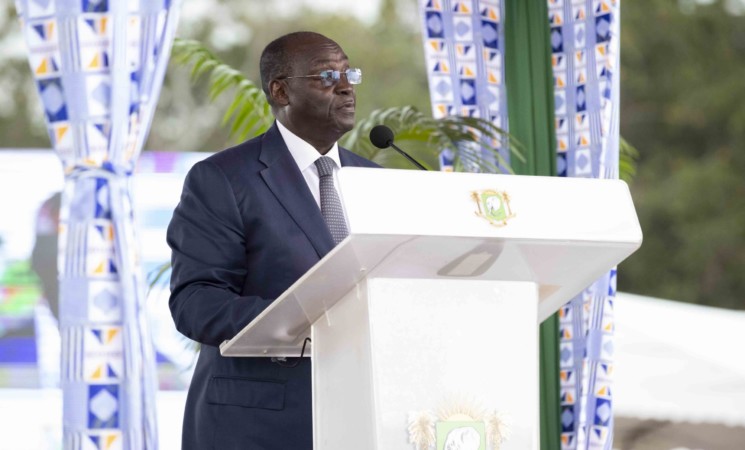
171, 38, 274, 141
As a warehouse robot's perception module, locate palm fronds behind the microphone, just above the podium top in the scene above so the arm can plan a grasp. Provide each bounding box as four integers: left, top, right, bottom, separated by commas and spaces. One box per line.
342, 106, 524, 173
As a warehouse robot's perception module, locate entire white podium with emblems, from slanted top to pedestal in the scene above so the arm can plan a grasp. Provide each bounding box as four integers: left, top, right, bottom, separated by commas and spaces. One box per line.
220, 168, 642, 450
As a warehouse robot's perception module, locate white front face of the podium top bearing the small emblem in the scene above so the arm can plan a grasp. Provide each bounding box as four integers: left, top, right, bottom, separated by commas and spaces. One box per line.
339, 168, 642, 242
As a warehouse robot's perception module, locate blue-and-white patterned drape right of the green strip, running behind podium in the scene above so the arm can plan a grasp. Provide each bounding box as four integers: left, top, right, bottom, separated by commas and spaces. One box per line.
548, 0, 620, 450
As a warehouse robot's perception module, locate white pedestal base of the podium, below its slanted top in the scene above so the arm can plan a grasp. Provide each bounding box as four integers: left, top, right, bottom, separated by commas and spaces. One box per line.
312, 277, 539, 450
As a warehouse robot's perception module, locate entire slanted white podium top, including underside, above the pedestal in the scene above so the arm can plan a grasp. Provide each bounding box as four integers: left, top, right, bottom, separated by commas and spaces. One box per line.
220, 168, 642, 356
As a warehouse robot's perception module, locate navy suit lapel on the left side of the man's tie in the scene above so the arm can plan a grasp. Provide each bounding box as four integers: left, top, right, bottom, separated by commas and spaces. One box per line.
259, 124, 334, 258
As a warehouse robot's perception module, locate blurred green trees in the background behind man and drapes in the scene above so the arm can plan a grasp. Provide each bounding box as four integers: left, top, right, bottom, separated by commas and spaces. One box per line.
0, 0, 745, 309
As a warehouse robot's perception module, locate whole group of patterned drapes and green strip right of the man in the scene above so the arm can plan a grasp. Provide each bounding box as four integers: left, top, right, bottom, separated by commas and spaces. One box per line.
420, 0, 620, 449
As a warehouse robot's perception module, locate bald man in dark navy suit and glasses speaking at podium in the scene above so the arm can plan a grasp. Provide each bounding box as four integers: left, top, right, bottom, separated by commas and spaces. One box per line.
168, 32, 375, 450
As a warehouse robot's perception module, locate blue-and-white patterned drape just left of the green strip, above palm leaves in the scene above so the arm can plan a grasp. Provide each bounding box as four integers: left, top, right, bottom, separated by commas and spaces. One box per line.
420, 0, 509, 170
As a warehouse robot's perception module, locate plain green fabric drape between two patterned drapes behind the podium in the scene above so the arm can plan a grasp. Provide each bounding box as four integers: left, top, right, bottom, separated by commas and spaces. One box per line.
504, 0, 561, 450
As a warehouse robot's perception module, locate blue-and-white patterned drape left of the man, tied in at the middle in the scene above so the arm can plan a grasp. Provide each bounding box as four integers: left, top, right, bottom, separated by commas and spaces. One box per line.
16, 0, 180, 449
